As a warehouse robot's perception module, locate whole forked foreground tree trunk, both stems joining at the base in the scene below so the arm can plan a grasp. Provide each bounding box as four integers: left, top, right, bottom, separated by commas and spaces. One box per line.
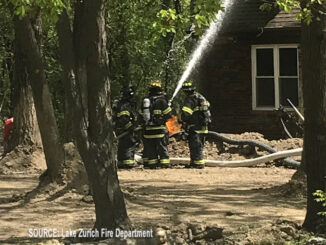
57, 0, 130, 229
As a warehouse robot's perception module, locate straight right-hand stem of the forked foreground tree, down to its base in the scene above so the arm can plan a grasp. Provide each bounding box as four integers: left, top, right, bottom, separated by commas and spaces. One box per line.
82, 0, 130, 228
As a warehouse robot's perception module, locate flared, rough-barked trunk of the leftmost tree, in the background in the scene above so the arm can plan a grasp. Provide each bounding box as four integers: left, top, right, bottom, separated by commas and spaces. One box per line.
6, 27, 42, 153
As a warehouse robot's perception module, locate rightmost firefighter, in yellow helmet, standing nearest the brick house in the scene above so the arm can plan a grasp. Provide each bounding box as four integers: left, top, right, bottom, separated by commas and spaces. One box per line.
181, 81, 211, 168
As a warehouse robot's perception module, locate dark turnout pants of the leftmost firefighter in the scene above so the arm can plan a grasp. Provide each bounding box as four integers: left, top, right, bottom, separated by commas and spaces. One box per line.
118, 132, 136, 165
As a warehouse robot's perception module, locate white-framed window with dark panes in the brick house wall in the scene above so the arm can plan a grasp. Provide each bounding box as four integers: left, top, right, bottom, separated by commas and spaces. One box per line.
251, 45, 299, 110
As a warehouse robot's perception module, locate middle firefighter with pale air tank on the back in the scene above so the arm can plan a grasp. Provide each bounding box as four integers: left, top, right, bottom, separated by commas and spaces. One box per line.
140, 81, 172, 169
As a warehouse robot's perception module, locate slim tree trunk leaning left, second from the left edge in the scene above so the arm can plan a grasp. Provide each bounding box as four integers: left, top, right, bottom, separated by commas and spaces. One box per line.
14, 16, 64, 180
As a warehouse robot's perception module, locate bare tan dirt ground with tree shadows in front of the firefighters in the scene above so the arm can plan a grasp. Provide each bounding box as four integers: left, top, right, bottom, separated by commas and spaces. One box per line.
0, 134, 305, 244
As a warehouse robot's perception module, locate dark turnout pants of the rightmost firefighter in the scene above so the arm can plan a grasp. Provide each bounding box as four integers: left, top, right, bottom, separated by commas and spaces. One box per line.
188, 132, 205, 164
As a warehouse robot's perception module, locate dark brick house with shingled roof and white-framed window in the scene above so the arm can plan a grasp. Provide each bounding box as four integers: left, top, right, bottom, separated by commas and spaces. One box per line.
196, 0, 302, 138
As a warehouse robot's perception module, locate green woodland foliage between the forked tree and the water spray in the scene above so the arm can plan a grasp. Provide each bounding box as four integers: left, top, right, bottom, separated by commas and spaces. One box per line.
107, 0, 223, 106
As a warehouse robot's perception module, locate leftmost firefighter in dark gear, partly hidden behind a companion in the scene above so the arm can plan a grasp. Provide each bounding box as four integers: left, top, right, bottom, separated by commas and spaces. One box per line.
115, 85, 137, 168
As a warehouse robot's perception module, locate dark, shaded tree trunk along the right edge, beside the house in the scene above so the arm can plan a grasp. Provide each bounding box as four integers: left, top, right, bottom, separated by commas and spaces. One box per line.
301, 3, 326, 231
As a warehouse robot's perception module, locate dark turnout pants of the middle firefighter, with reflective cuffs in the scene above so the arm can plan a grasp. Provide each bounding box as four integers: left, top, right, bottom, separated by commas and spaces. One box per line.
147, 133, 170, 166
